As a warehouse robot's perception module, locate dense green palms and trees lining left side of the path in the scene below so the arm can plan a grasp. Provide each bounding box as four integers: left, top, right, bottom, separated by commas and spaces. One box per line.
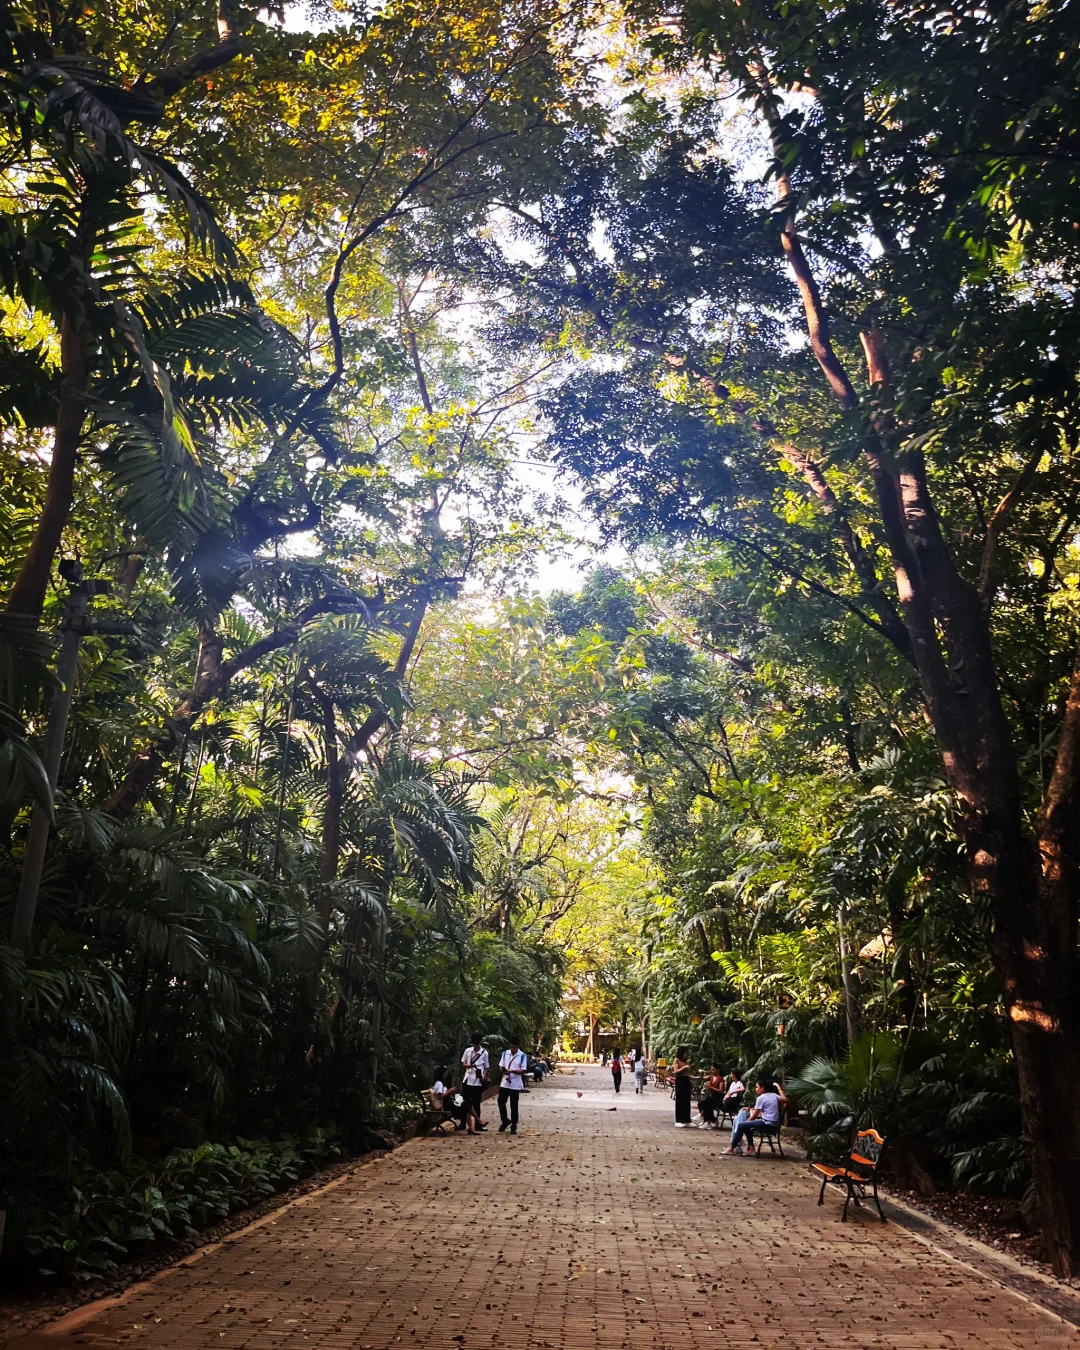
0, 5, 569, 1266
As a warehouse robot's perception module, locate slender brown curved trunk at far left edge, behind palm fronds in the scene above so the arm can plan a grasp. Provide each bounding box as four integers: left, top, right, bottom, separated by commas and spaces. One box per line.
7, 311, 86, 620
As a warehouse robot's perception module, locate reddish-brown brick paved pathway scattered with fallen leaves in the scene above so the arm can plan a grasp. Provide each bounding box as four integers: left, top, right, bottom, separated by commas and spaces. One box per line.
18, 1069, 1080, 1350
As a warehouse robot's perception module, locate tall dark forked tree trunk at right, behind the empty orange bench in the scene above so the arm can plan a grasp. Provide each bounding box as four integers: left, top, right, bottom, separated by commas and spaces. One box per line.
747, 97, 1080, 1277
